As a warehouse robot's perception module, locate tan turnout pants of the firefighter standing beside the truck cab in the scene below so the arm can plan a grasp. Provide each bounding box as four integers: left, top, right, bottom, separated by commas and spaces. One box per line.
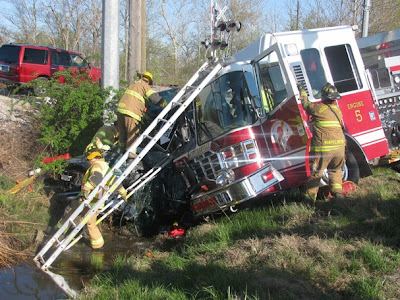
304, 147, 345, 201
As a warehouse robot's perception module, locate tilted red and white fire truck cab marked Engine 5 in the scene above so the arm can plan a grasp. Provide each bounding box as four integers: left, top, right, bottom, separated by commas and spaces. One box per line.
170, 26, 389, 215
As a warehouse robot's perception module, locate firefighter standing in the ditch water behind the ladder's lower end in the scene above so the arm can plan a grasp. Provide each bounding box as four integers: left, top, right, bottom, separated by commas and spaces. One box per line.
57, 146, 127, 249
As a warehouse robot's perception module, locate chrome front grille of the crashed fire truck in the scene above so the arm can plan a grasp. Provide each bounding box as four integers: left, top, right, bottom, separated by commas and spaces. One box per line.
189, 151, 221, 180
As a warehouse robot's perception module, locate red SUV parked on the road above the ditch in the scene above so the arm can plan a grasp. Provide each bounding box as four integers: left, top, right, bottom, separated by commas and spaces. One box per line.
0, 44, 101, 85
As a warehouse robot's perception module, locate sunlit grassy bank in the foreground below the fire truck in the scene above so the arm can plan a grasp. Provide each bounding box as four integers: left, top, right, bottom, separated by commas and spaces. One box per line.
80, 168, 400, 300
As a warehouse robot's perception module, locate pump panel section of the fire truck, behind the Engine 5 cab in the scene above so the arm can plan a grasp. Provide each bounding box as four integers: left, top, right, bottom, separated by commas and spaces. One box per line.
357, 29, 400, 164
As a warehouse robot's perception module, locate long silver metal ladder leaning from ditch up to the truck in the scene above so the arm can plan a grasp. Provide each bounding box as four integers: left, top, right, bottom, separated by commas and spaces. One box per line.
33, 62, 222, 276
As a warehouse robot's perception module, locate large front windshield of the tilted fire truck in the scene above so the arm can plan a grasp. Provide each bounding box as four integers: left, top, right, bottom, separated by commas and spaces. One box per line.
196, 71, 256, 144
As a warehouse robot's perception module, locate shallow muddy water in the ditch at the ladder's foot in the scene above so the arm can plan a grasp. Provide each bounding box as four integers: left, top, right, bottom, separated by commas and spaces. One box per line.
0, 233, 159, 300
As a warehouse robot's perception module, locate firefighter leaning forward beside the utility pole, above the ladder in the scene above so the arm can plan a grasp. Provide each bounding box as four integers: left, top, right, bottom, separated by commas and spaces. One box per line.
117, 72, 168, 158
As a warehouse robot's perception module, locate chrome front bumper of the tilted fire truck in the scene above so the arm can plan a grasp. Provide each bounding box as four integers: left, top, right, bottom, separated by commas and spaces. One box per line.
191, 165, 283, 215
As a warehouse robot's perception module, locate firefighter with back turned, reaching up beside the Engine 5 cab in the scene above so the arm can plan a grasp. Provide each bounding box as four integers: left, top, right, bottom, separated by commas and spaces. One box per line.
300, 83, 346, 203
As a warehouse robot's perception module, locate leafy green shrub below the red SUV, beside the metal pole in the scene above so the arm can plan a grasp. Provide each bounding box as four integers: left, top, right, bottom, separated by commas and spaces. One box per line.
26, 71, 119, 156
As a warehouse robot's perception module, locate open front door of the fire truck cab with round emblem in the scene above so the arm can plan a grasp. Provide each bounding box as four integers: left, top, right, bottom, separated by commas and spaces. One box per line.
253, 44, 308, 185
